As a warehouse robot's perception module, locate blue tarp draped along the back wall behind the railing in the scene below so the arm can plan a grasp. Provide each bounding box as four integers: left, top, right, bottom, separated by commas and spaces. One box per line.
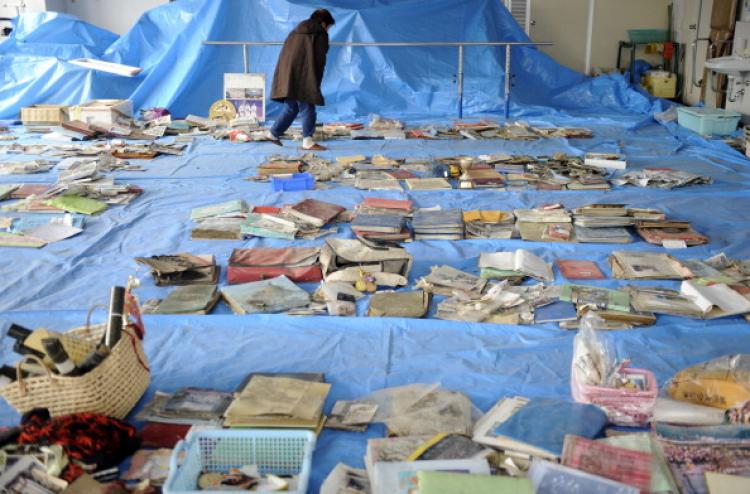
0, 0, 664, 118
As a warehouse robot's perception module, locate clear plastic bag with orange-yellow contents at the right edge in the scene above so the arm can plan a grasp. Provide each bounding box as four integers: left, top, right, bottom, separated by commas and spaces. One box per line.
665, 354, 750, 410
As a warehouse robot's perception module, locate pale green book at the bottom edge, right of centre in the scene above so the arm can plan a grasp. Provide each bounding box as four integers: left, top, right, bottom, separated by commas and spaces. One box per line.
417, 472, 534, 494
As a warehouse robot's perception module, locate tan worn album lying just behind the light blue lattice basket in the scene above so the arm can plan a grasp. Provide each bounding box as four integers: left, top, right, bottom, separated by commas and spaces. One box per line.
224, 374, 331, 430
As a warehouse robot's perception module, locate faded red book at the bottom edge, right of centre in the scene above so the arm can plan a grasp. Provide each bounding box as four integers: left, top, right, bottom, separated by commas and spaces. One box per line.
562, 436, 651, 493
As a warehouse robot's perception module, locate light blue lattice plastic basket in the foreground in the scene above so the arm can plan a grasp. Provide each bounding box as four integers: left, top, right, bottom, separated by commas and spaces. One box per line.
163, 429, 316, 494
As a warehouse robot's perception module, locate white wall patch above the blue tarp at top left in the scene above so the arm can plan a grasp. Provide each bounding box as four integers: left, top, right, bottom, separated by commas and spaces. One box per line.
59, 0, 168, 34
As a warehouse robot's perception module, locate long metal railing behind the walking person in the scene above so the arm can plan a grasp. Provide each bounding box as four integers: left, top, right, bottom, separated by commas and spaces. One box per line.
203, 41, 552, 120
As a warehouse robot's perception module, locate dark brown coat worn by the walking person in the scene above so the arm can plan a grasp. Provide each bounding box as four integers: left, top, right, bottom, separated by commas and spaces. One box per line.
271, 19, 328, 106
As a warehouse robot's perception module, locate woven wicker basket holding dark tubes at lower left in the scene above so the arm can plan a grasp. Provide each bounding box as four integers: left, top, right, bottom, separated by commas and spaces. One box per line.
0, 325, 150, 419
